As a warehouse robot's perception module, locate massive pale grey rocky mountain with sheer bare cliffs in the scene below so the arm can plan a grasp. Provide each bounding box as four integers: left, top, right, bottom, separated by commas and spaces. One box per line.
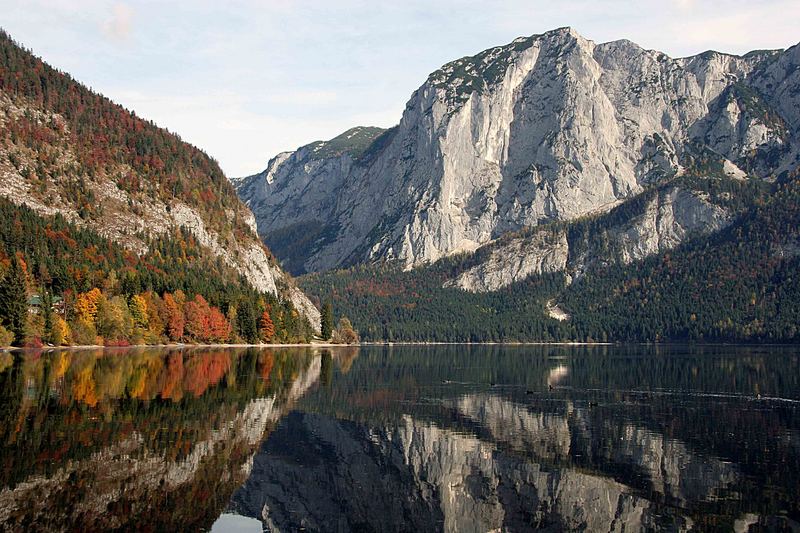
236, 28, 800, 278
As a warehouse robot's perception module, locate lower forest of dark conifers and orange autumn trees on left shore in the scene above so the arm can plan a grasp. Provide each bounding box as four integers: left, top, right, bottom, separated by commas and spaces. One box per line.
0, 199, 313, 345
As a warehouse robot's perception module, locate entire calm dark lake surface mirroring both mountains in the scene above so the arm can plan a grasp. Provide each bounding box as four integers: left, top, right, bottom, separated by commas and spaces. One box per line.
0, 346, 800, 532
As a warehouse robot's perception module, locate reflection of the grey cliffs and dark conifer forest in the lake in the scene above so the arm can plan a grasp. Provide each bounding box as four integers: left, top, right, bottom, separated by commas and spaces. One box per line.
230, 347, 800, 531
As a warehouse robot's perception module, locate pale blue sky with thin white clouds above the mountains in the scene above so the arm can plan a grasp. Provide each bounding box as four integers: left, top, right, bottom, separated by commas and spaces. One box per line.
0, 0, 800, 177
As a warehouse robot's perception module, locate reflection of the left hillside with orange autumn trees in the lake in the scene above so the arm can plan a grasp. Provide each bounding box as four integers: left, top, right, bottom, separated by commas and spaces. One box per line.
0, 349, 320, 531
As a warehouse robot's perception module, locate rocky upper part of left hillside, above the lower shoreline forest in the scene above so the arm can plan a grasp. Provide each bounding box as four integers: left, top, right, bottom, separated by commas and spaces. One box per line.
0, 32, 319, 327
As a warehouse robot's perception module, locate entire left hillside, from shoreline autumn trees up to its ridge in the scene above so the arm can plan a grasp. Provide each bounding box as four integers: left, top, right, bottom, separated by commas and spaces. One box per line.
0, 31, 319, 345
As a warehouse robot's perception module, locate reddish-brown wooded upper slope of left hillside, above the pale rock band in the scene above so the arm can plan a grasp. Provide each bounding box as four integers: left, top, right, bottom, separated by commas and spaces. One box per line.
0, 30, 248, 234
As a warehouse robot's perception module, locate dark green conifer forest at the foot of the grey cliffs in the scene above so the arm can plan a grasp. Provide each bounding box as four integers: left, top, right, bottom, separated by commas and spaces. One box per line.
301, 172, 800, 342
